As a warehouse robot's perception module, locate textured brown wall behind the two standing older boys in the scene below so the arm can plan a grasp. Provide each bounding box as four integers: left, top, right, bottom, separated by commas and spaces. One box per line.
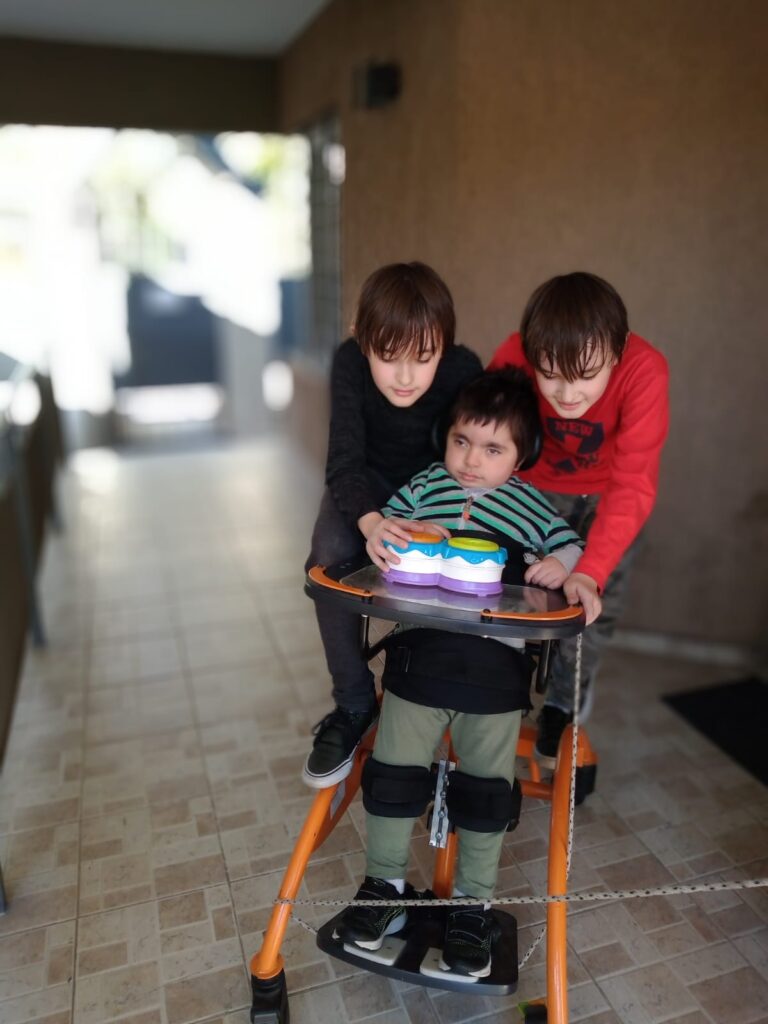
281, 0, 768, 645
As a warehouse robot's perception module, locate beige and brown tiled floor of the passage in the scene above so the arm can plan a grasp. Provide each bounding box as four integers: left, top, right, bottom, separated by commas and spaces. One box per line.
0, 442, 768, 1024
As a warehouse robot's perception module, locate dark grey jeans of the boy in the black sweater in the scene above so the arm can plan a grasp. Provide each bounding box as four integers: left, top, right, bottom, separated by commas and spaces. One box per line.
304, 473, 396, 712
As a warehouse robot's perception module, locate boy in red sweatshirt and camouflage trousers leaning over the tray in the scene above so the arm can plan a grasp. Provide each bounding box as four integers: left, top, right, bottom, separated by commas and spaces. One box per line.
488, 272, 669, 766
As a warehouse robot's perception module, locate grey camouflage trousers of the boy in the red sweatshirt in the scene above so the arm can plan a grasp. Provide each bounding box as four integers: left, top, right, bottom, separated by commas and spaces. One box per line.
542, 490, 642, 712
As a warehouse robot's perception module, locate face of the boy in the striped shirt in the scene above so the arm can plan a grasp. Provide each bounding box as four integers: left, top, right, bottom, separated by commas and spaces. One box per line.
445, 420, 520, 490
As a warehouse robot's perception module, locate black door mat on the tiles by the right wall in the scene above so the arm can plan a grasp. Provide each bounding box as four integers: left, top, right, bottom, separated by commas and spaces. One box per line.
664, 677, 768, 785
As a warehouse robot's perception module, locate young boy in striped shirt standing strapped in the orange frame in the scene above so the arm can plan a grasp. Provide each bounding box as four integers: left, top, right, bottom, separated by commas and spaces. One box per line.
339, 369, 600, 977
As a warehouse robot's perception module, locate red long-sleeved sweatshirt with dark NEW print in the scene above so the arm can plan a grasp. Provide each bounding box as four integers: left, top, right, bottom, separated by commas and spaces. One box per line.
488, 333, 669, 589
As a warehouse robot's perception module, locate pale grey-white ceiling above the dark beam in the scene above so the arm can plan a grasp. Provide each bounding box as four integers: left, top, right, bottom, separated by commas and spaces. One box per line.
0, 0, 329, 55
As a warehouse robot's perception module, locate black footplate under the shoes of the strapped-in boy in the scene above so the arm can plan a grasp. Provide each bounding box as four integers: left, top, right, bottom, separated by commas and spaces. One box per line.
317, 906, 517, 995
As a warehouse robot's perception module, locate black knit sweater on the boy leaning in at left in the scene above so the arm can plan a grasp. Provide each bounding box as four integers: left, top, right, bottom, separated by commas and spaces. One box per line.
326, 338, 482, 522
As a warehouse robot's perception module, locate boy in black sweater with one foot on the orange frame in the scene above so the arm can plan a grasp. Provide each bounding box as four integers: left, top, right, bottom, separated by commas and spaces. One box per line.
303, 263, 482, 788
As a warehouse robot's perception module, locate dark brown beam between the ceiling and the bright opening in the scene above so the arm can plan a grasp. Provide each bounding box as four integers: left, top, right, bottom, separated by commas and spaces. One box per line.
0, 37, 278, 131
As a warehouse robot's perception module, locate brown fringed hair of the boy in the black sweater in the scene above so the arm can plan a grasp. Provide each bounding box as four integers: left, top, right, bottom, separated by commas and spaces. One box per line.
353, 263, 456, 359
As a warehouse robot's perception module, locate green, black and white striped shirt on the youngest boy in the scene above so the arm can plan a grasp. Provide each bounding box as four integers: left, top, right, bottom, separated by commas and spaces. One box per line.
381, 462, 584, 572
